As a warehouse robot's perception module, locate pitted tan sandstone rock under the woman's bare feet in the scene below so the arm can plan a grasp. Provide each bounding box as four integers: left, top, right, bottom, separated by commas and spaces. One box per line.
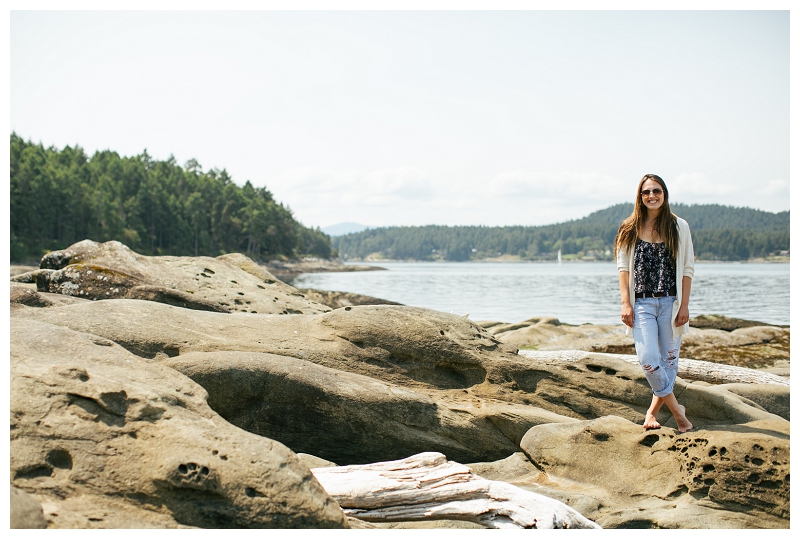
521, 416, 789, 528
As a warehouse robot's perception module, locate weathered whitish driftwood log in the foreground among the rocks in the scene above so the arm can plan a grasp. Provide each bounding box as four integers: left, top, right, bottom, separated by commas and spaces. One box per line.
311, 452, 600, 529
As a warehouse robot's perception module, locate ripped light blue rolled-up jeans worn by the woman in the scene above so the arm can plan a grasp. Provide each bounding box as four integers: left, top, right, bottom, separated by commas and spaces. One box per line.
633, 296, 681, 397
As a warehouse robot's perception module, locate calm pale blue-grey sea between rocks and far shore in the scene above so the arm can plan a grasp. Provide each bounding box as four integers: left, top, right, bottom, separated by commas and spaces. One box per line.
292, 262, 789, 324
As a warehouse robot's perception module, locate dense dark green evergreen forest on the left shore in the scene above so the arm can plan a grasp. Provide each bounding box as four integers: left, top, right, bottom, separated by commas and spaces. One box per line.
10, 133, 333, 261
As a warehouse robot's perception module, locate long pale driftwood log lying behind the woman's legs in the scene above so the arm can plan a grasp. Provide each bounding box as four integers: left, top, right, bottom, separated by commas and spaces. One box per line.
519, 350, 789, 386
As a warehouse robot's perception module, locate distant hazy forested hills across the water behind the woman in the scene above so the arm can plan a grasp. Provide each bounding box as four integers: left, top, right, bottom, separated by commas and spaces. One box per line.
332, 203, 789, 261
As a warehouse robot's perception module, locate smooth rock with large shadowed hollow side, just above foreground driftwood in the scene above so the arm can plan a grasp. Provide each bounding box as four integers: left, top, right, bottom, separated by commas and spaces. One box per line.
163, 352, 574, 464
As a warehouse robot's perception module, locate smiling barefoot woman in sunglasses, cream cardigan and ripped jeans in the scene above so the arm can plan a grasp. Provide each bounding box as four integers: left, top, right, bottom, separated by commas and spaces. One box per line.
614, 174, 694, 432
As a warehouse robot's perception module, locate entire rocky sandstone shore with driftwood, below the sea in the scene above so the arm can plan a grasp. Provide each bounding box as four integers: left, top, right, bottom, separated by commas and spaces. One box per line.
10, 240, 790, 529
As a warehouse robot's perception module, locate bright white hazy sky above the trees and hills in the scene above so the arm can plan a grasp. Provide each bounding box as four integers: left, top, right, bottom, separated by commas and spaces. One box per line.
10, 6, 789, 227
